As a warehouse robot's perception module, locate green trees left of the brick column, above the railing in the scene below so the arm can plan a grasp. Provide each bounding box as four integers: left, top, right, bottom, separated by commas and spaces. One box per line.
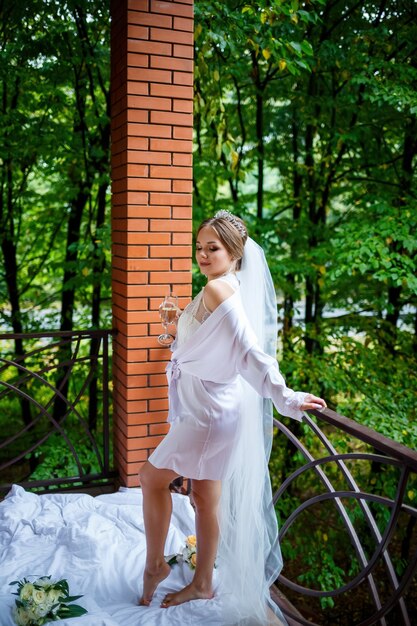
0, 0, 110, 332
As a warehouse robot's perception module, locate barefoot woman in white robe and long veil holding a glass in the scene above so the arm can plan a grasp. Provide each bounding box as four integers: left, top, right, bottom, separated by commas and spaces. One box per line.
140, 211, 325, 626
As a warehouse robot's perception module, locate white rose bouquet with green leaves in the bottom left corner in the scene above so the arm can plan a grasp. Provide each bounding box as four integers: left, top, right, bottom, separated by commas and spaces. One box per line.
10, 576, 87, 626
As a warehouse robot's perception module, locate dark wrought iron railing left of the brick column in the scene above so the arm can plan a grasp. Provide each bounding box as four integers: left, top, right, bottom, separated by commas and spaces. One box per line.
0, 330, 115, 497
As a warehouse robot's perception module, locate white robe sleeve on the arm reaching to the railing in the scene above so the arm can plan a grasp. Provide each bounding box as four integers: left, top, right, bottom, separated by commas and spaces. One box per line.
238, 345, 308, 421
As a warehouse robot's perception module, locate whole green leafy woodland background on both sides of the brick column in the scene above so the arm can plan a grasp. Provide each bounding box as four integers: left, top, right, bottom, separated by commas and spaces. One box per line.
0, 0, 417, 624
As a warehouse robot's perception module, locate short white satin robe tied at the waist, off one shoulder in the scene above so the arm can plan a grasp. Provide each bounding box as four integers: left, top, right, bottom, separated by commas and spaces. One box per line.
149, 289, 306, 480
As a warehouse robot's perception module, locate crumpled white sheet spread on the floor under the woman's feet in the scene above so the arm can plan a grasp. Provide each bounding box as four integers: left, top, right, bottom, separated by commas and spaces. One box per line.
0, 486, 224, 626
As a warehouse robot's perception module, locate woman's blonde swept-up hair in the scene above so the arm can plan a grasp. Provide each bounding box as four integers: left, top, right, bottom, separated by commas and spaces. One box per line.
197, 211, 248, 270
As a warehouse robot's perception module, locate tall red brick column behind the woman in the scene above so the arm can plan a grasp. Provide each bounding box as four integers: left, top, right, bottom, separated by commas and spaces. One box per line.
111, 0, 193, 486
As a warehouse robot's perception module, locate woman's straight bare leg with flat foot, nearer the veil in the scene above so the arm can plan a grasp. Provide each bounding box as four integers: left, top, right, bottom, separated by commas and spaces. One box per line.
161, 480, 221, 608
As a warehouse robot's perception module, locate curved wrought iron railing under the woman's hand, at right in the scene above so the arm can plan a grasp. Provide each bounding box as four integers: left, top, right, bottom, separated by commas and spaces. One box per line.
274, 409, 417, 626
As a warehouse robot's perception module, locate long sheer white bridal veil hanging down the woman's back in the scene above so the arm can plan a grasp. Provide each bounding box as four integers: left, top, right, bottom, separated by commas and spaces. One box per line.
219, 238, 285, 626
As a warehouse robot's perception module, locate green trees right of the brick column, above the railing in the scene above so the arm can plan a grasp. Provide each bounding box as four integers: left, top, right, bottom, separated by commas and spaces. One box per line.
194, 0, 417, 428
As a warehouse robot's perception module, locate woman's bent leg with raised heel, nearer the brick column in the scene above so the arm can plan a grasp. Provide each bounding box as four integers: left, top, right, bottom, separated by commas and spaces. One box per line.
139, 462, 178, 606
